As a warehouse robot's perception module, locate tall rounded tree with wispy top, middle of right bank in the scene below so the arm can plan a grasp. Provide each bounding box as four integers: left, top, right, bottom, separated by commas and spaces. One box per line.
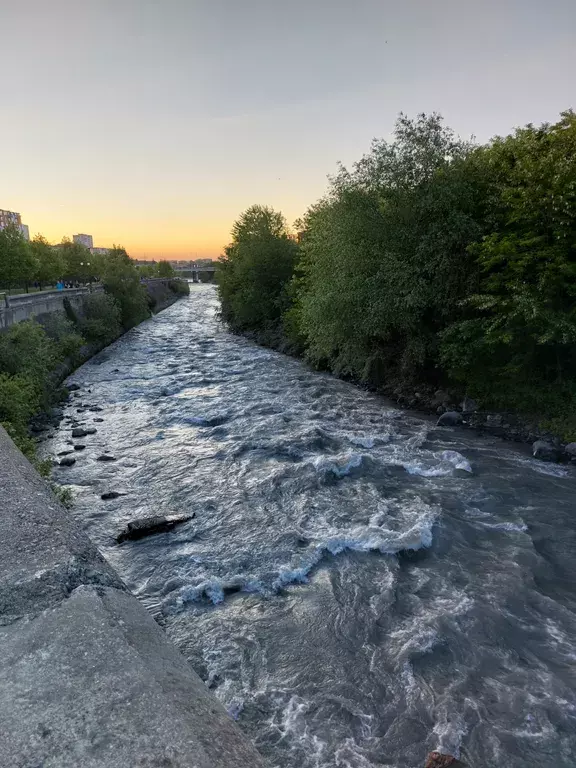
296, 114, 483, 384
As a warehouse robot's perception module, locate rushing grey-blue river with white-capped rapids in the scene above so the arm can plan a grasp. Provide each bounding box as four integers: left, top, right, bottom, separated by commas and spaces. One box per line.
45, 286, 576, 768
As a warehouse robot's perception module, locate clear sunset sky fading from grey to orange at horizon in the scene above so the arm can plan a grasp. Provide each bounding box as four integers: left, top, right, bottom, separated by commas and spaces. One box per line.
0, 0, 576, 258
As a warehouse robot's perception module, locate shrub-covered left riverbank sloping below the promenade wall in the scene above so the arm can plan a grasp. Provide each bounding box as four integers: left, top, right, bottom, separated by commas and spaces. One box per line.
0, 278, 189, 464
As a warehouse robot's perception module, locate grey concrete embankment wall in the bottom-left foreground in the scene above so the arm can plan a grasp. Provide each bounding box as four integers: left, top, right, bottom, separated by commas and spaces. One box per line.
0, 427, 264, 768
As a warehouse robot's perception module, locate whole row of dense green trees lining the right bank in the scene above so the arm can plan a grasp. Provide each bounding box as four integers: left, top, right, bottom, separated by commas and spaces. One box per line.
219, 112, 576, 437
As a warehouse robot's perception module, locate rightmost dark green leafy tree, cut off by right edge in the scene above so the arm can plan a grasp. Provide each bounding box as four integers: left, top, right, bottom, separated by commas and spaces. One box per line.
443, 112, 576, 410
